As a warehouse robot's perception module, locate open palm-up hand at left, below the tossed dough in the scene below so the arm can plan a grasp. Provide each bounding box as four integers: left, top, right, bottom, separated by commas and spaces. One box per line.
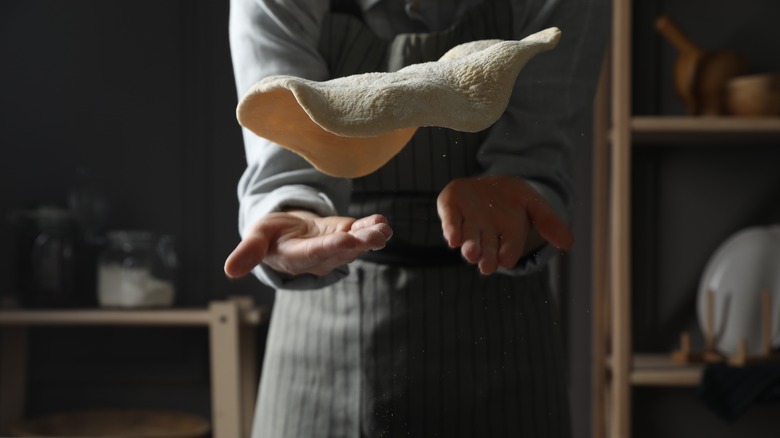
225, 210, 393, 278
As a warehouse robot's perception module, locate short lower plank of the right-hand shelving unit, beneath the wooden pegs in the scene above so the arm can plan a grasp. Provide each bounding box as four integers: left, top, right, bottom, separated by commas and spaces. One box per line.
607, 353, 703, 387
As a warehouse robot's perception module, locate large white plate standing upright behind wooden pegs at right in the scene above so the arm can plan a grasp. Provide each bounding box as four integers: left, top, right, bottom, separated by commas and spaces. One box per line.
697, 225, 780, 355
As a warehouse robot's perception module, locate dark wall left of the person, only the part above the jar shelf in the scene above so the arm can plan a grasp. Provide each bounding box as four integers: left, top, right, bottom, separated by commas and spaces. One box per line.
0, 1, 266, 305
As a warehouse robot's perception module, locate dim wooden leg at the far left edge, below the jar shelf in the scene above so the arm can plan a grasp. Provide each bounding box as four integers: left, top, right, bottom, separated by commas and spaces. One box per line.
0, 327, 27, 436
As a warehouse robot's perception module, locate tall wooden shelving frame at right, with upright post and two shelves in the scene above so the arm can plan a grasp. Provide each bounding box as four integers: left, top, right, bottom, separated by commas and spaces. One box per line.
592, 0, 780, 438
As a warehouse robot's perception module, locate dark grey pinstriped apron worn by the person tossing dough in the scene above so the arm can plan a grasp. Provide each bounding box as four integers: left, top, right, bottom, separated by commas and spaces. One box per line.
253, 0, 570, 438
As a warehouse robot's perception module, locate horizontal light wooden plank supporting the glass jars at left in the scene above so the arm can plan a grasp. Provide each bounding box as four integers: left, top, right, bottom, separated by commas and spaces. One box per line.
0, 308, 264, 326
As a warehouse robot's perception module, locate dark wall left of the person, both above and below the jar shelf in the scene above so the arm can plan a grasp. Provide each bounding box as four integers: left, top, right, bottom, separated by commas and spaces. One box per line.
0, 0, 271, 424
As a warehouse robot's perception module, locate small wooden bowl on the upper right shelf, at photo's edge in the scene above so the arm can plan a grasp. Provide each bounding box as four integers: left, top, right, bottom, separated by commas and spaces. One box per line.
726, 72, 780, 117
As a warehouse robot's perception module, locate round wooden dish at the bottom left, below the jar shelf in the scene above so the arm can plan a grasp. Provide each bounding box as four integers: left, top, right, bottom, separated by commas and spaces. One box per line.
10, 409, 210, 438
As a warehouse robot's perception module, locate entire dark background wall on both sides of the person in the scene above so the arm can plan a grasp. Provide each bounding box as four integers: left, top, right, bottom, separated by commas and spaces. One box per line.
0, 0, 780, 437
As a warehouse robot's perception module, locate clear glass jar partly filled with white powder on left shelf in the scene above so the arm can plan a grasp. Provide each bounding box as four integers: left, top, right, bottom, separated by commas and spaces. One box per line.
98, 231, 177, 307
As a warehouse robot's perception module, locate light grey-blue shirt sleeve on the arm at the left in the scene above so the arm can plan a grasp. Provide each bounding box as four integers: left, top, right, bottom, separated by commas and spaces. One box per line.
229, 0, 351, 289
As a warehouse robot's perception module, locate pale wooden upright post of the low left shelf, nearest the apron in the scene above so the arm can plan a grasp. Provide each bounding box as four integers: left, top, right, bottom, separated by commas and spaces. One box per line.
209, 301, 242, 438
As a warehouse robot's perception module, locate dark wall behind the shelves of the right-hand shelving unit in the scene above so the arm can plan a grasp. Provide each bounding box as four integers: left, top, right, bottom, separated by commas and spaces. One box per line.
632, 0, 780, 438
